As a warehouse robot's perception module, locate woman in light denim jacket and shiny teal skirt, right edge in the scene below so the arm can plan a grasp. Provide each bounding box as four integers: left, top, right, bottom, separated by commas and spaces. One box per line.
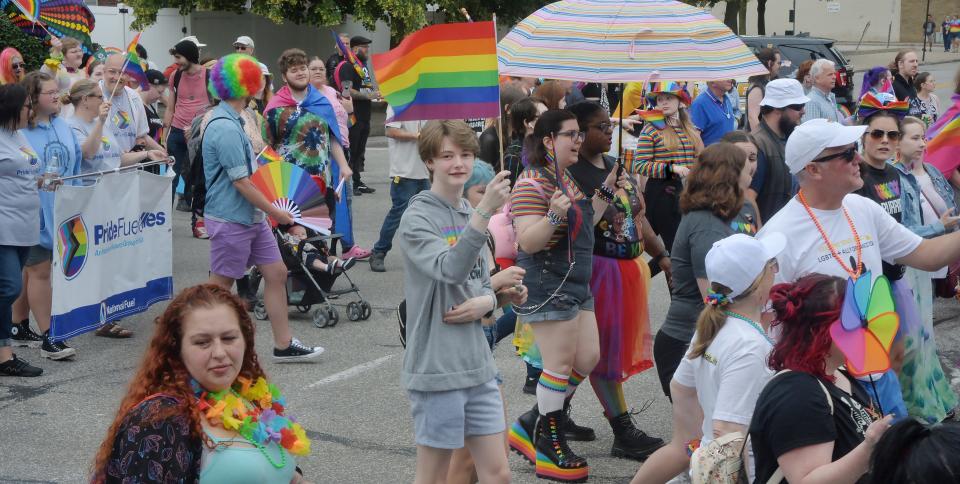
894, 117, 960, 423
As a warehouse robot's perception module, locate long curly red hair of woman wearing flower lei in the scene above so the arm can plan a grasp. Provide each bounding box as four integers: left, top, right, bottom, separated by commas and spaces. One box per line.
93, 286, 265, 480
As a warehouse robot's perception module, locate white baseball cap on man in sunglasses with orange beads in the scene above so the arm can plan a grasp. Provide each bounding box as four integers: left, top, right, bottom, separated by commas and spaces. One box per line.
784, 119, 867, 175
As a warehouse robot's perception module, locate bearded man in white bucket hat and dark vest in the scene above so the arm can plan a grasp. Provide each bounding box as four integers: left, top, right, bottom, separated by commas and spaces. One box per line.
747, 79, 810, 221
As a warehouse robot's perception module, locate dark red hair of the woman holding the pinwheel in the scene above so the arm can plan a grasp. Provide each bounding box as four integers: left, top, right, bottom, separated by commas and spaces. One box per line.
769, 274, 846, 382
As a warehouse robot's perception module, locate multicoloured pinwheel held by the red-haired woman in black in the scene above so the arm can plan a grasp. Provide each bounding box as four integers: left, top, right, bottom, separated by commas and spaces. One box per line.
830, 271, 900, 376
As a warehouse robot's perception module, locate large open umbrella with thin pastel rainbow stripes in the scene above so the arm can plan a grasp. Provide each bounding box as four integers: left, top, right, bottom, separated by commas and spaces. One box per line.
497, 0, 768, 82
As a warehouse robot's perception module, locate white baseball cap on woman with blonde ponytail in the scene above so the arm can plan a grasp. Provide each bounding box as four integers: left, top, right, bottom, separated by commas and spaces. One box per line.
705, 232, 787, 299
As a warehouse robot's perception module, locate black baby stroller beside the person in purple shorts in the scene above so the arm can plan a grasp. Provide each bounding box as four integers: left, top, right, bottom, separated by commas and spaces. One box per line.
250, 228, 372, 328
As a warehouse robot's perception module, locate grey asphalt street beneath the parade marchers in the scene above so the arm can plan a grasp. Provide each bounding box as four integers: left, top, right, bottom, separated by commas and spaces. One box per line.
0, 58, 960, 483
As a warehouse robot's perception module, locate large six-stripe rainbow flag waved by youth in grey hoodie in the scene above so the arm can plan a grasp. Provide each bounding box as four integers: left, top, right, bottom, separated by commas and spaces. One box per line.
373, 21, 500, 121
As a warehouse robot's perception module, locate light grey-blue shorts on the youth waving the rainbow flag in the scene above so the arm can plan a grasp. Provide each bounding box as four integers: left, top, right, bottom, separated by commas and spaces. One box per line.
407, 379, 506, 449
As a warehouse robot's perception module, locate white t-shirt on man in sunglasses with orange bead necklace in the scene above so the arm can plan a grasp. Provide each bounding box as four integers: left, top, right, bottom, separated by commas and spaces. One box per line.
757, 194, 923, 283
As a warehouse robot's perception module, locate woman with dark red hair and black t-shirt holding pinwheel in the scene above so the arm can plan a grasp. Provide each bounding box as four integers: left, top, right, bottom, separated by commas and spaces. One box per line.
750, 274, 892, 484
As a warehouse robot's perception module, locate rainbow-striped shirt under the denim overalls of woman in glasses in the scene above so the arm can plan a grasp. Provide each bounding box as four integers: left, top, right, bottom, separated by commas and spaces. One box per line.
510, 165, 587, 248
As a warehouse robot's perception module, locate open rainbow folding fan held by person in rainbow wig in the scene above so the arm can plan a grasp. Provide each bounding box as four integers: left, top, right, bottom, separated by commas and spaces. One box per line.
250, 161, 325, 219
